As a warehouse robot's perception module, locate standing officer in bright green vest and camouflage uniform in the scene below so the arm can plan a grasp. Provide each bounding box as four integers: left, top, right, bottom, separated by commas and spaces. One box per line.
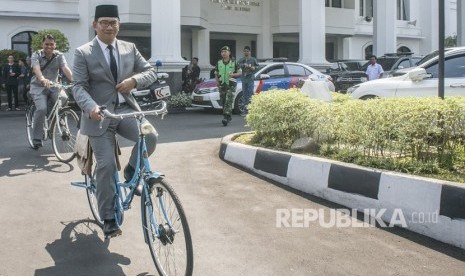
215, 46, 242, 126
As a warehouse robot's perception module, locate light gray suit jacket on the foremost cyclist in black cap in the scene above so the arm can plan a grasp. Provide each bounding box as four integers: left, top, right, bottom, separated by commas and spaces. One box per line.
73, 38, 157, 136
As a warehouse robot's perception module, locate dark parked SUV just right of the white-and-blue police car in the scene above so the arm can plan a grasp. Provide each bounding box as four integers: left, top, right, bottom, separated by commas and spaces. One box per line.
326, 60, 368, 93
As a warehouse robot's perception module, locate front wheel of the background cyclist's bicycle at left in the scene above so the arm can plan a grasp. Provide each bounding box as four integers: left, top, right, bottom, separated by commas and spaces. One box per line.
52, 108, 79, 163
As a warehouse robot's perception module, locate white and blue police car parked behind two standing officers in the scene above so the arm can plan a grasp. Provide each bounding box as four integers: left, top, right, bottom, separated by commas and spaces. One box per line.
191, 61, 334, 113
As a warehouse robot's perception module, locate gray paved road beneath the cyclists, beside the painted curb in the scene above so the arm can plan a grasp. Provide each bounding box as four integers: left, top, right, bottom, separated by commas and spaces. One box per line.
0, 109, 465, 276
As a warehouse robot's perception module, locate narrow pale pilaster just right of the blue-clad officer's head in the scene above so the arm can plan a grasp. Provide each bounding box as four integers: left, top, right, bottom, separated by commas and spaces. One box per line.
257, 1, 273, 58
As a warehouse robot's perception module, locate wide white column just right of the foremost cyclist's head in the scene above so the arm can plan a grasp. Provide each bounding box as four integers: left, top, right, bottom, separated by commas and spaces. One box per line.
149, 0, 189, 71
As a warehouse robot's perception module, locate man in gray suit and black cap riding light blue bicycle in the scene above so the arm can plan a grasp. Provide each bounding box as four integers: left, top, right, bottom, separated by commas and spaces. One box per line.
73, 5, 157, 237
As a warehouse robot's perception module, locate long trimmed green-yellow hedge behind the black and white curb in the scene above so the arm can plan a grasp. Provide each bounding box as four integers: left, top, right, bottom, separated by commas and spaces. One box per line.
246, 89, 465, 181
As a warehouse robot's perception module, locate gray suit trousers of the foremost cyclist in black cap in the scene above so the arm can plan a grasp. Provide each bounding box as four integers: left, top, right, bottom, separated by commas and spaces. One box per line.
89, 106, 157, 220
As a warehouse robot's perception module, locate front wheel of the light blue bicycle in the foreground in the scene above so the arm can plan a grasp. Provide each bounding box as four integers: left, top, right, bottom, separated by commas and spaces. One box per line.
141, 180, 194, 275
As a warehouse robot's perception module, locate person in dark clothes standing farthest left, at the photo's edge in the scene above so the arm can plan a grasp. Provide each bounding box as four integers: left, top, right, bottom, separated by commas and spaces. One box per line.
2, 56, 21, 111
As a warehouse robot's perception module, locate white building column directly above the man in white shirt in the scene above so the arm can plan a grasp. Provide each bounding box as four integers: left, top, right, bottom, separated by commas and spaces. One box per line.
373, 0, 397, 56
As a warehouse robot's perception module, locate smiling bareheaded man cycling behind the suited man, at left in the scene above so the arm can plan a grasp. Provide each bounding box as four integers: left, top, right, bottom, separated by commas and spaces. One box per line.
30, 34, 73, 149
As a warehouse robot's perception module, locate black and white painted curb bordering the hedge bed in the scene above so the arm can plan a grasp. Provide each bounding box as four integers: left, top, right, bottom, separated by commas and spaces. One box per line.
219, 134, 465, 249
